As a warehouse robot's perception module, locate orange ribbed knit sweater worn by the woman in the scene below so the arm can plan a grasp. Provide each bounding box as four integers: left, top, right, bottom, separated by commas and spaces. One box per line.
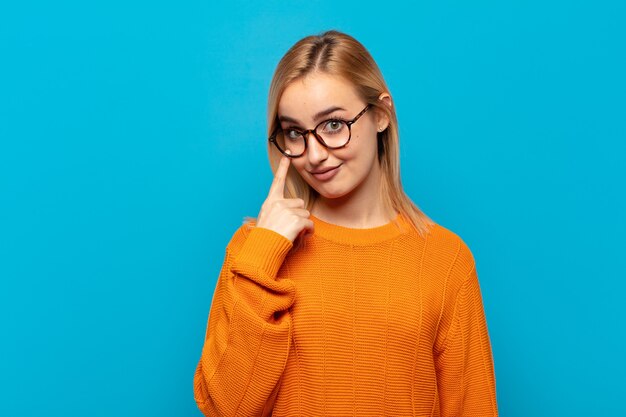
194, 215, 498, 417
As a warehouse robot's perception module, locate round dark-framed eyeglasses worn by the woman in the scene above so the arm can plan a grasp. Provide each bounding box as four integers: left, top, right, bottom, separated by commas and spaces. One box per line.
269, 104, 370, 158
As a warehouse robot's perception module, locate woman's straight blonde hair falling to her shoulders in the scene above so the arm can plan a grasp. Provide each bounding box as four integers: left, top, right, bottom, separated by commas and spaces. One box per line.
244, 30, 435, 248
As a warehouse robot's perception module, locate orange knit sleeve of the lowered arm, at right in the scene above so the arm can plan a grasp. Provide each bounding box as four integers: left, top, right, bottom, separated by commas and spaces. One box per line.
434, 264, 498, 417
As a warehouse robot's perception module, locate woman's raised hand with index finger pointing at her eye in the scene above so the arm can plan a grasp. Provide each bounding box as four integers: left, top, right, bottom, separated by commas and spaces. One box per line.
256, 150, 313, 242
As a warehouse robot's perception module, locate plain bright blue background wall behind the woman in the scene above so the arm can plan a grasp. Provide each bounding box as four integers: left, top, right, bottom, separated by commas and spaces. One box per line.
0, 0, 626, 417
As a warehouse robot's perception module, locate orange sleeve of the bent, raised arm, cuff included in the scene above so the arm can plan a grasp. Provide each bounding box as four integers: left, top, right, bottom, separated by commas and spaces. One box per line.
194, 225, 295, 417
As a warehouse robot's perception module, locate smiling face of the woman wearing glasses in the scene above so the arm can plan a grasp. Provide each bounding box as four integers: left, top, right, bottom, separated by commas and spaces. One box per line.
278, 73, 387, 199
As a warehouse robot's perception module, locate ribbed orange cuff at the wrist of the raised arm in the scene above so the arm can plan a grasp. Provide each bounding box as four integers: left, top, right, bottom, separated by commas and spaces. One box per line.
236, 226, 293, 278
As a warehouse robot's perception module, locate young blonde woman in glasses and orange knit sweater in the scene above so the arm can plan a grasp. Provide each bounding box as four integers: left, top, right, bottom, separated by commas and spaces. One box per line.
194, 31, 498, 417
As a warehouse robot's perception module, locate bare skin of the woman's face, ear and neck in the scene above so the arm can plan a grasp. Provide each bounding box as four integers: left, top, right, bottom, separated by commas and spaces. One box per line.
278, 72, 391, 228
